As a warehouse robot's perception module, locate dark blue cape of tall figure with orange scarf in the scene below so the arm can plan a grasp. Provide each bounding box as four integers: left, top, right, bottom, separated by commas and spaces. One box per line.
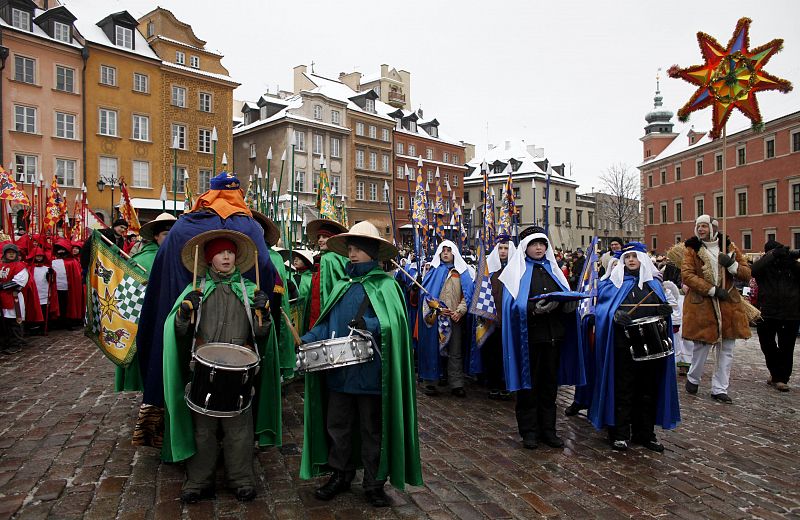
136, 212, 275, 407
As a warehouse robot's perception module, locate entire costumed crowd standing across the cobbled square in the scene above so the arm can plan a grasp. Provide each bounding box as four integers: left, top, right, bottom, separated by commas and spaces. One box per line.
0, 172, 800, 507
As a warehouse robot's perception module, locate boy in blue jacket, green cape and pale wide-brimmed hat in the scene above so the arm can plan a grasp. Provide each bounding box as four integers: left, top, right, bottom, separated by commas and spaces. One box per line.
300, 221, 422, 507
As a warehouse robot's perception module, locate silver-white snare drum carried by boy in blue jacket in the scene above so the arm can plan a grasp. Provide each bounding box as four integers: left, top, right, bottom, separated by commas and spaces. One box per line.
295, 329, 375, 372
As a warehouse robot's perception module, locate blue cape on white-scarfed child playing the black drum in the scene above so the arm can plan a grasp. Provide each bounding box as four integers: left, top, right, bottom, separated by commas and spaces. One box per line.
589, 275, 681, 430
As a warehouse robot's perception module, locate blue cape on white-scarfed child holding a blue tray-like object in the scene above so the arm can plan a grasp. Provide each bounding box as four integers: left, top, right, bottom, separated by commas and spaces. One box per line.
496, 258, 586, 392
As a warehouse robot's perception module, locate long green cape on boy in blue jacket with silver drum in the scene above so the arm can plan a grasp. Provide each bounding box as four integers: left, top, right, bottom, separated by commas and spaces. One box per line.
300, 266, 422, 490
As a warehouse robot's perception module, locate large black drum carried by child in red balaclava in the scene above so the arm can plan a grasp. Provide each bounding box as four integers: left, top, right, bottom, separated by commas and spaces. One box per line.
185, 343, 259, 417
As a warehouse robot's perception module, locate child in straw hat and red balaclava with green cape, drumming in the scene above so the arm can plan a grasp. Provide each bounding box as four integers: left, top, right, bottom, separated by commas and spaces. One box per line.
163, 230, 280, 503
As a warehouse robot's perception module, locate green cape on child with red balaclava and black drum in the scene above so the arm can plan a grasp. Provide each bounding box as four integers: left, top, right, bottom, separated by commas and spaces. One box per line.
161, 269, 281, 462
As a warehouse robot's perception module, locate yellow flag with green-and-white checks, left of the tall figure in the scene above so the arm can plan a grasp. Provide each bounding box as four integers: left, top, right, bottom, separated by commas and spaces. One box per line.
85, 231, 149, 367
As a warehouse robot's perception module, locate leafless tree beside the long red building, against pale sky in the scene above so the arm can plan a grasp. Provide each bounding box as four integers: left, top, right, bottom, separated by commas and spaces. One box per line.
596, 163, 640, 230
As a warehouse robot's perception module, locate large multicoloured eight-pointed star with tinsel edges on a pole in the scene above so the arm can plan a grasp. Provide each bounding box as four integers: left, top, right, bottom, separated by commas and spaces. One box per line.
669, 18, 792, 139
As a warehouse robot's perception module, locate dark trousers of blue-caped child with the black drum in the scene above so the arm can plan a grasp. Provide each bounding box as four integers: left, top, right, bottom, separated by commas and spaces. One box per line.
609, 344, 665, 442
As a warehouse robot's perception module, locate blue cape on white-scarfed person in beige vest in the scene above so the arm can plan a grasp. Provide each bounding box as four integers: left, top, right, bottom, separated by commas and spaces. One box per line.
417, 264, 475, 381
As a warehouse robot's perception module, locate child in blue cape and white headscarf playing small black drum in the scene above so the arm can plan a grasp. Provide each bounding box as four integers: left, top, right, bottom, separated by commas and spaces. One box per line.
589, 242, 680, 452
